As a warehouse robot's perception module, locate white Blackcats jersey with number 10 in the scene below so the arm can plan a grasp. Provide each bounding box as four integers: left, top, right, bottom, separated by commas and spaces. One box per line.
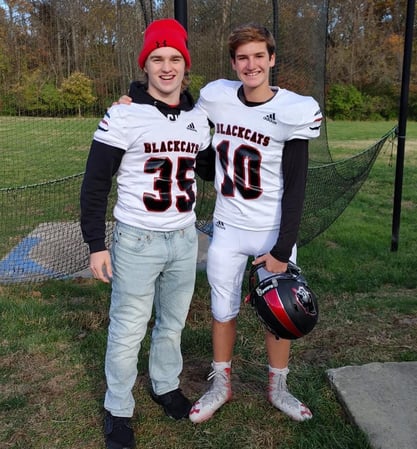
197, 79, 322, 231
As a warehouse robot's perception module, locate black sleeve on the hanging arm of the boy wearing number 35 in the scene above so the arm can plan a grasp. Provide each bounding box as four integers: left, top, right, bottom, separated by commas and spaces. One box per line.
80, 140, 124, 253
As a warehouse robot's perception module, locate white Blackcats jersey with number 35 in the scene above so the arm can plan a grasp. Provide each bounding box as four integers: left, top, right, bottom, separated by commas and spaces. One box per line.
94, 103, 211, 231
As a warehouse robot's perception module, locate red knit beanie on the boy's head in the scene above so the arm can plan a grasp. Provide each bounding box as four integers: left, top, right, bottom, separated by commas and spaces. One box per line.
138, 19, 191, 69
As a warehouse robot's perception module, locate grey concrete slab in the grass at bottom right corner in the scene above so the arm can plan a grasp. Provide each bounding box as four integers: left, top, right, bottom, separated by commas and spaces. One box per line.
326, 362, 417, 449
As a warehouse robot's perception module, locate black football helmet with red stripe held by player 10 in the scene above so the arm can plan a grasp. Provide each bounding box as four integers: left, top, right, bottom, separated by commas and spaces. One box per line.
246, 262, 319, 340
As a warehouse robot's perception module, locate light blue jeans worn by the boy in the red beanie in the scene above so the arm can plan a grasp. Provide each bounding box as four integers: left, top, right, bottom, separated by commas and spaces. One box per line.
104, 222, 198, 417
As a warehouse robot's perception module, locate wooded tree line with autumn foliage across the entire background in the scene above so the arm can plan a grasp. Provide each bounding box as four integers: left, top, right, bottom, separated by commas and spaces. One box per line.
0, 0, 417, 119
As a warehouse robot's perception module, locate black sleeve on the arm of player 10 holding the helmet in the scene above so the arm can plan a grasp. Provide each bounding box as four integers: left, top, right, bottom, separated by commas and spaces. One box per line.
270, 139, 308, 262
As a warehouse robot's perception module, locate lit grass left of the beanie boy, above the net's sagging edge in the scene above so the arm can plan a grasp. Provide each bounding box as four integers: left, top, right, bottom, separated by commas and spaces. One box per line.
0, 116, 99, 188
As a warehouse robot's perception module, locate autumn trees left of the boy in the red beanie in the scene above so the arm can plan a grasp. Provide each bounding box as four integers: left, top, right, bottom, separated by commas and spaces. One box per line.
0, 0, 152, 115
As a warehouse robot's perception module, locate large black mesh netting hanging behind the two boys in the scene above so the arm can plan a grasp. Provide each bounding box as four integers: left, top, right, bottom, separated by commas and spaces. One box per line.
0, 0, 393, 283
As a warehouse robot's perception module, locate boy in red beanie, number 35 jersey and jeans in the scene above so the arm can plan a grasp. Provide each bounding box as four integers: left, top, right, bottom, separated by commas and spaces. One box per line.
80, 19, 210, 449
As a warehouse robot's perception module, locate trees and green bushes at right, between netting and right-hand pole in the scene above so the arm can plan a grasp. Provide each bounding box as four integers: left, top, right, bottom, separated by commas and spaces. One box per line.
327, 0, 417, 120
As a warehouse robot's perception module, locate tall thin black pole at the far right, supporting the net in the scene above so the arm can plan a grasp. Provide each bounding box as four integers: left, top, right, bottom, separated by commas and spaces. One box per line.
391, 0, 415, 251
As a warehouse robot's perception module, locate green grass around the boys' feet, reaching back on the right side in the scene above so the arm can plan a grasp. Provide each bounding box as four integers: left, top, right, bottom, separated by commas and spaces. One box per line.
0, 122, 417, 449
